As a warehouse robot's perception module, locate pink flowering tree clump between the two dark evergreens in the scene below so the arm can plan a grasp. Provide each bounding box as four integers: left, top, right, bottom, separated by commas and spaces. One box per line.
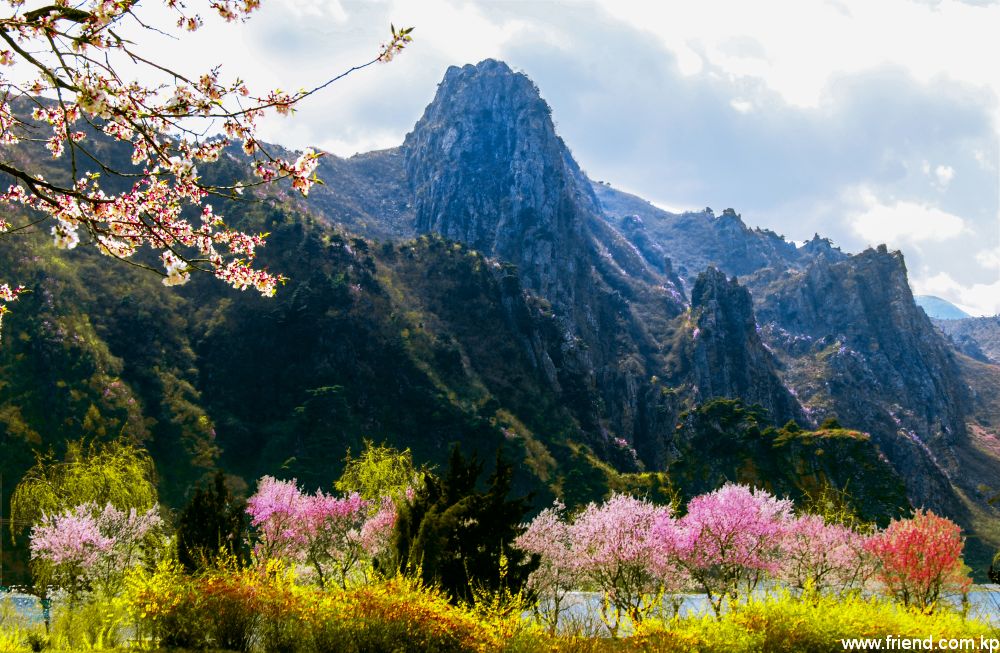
247, 476, 396, 587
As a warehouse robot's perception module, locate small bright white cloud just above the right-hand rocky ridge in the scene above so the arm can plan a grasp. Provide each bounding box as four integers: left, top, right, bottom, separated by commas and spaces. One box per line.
850, 189, 967, 246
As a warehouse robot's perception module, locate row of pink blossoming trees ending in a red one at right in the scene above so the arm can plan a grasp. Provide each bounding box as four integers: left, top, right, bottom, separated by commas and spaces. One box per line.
516, 484, 969, 634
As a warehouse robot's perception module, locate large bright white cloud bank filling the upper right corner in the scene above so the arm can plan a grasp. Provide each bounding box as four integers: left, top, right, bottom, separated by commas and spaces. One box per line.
604, 0, 1000, 106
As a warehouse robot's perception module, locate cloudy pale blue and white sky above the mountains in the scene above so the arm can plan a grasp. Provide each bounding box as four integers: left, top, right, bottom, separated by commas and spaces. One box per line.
135, 0, 1000, 314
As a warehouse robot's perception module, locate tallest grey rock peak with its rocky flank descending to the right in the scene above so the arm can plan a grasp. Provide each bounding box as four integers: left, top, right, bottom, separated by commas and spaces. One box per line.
403, 60, 696, 458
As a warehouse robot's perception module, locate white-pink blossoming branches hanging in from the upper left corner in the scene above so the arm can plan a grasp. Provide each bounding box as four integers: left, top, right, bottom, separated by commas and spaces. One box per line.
0, 0, 410, 318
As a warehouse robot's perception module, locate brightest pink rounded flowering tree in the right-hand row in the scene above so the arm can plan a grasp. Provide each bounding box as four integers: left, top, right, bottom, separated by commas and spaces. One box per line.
653, 483, 792, 615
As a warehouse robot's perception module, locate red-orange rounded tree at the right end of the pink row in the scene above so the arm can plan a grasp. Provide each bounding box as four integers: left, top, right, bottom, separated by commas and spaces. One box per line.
866, 510, 972, 611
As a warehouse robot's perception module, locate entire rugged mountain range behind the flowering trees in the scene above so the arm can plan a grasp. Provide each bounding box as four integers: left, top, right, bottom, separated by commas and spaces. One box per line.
0, 60, 1000, 574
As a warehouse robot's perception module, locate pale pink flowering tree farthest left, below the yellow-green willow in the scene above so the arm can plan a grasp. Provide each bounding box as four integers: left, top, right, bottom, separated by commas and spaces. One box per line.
31, 504, 161, 603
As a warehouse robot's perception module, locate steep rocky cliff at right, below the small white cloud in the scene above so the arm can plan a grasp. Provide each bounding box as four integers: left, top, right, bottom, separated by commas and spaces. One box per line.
750, 247, 970, 512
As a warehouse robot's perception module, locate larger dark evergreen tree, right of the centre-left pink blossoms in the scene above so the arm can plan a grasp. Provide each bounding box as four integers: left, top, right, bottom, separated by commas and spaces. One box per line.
395, 445, 538, 602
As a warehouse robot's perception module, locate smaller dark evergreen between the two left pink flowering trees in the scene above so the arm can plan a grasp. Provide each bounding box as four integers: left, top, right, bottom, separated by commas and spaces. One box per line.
177, 471, 247, 572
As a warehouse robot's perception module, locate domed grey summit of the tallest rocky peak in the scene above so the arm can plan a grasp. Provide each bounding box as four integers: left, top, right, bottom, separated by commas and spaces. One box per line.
403, 59, 596, 290
